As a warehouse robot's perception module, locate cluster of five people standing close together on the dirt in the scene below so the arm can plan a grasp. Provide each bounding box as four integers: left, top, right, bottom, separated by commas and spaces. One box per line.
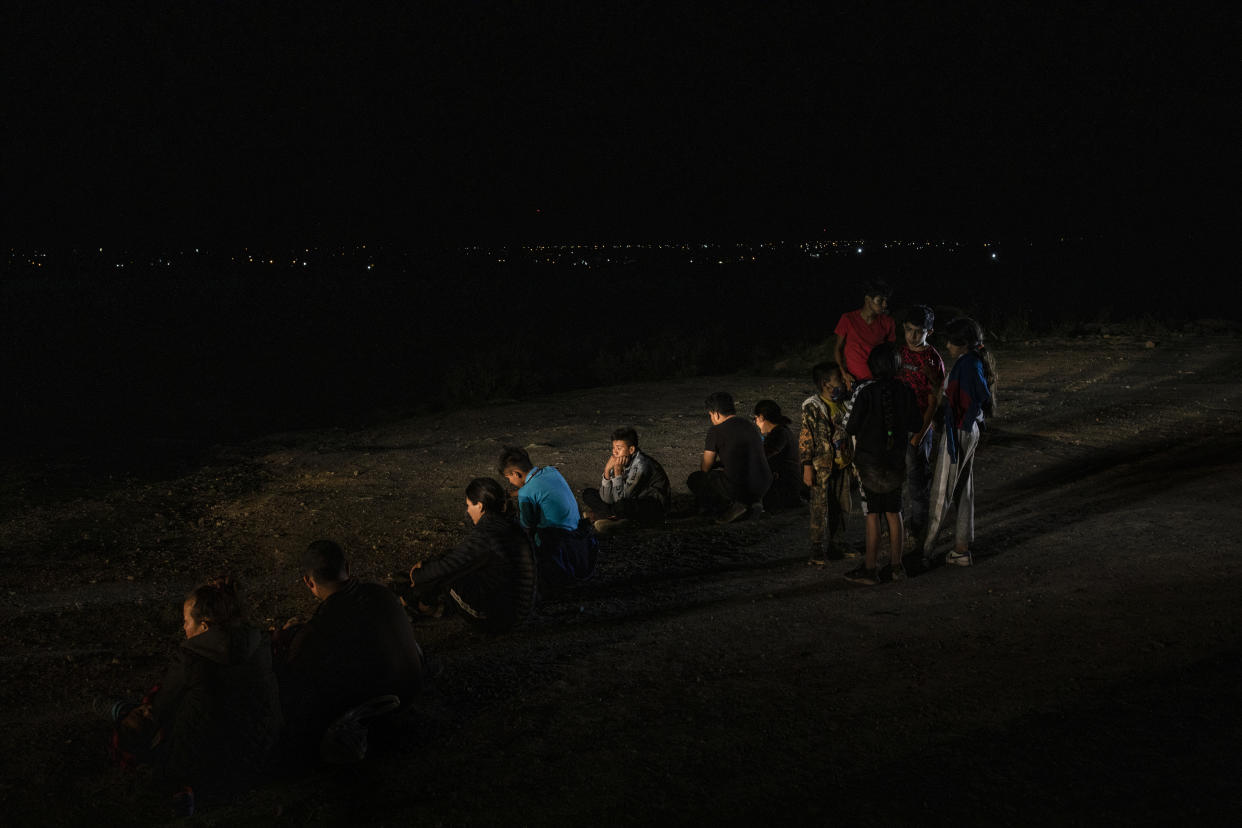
824, 282, 996, 583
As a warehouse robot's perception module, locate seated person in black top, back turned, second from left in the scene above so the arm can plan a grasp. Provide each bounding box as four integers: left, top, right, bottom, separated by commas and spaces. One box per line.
276, 540, 422, 747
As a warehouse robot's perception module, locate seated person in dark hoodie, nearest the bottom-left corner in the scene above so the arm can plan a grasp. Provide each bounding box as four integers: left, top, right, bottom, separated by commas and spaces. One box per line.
114, 576, 282, 809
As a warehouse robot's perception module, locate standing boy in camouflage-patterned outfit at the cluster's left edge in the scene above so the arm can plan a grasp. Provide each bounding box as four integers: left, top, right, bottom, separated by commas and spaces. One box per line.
797, 362, 858, 566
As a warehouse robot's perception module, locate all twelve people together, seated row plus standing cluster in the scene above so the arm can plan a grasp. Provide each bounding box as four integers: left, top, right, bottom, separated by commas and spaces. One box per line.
112, 276, 996, 809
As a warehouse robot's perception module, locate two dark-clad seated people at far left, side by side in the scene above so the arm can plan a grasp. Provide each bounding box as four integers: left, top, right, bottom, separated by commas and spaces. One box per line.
109, 540, 425, 814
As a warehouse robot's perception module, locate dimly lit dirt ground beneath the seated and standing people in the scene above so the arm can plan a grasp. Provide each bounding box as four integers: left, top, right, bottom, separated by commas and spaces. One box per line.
0, 334, 1242, 826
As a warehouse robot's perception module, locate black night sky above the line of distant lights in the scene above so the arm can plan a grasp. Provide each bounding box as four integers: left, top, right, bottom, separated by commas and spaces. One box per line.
2, 1, 1238, 246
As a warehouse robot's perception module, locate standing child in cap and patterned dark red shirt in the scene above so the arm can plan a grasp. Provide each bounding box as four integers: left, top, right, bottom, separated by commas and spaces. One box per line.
898, 304, 944, 543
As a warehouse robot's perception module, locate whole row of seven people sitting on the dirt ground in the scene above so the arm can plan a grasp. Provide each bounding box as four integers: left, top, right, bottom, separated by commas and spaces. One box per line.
109, 404, 799, 812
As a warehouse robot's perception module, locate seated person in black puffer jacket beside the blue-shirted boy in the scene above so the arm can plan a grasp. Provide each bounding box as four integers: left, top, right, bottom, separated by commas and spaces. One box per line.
410, 477, 535, 632
